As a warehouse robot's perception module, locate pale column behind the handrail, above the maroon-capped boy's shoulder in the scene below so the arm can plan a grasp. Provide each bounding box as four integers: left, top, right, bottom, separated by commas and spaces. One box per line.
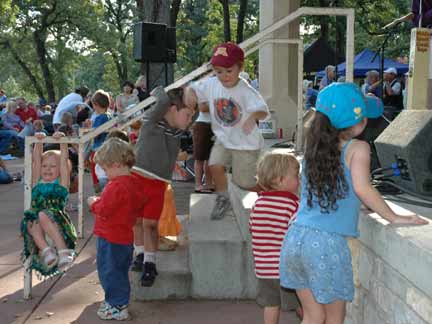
259, 0, 300, 138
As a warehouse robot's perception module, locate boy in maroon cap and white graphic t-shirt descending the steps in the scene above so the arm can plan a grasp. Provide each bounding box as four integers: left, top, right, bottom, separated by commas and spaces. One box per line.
186, 42, 269, 219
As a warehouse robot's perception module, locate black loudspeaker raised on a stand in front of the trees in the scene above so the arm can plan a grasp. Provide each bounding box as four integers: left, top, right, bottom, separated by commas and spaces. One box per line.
133, 22, 176, 63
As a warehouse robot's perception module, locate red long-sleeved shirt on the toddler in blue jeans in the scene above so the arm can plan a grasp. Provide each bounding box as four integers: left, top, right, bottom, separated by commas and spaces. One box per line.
91, 175, 147, 244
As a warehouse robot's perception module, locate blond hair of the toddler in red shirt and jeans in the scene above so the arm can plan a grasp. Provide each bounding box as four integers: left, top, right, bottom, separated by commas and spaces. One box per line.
94, 137, 135, 168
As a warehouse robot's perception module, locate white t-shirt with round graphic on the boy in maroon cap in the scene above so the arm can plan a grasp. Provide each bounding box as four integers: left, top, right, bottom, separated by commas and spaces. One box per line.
192, 77, 269, 150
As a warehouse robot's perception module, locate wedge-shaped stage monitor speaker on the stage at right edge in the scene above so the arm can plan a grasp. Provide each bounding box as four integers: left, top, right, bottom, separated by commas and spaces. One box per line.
375, 110, 432, 196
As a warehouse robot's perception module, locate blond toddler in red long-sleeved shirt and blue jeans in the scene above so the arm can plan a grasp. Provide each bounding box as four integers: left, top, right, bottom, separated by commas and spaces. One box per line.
87, 138, 146, 320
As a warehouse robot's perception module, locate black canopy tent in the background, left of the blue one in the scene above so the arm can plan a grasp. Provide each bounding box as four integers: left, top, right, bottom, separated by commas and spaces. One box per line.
303, 37, 345, 73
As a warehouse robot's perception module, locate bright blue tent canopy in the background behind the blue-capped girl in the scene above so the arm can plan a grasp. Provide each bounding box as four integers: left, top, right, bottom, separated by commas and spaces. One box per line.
317, 48, 408, 78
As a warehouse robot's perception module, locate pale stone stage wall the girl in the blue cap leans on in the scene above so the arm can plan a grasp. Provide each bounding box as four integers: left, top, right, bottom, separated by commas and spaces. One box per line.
345, 205, 432, 324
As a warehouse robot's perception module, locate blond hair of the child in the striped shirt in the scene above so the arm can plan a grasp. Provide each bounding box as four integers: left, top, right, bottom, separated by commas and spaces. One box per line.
257, 153, 300, 190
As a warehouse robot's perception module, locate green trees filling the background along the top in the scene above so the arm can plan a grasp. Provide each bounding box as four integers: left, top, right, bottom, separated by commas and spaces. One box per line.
0, 0, 409, 101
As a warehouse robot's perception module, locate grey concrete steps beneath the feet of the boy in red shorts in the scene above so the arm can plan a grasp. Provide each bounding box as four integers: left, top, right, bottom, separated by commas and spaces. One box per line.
130, 216, 192, 301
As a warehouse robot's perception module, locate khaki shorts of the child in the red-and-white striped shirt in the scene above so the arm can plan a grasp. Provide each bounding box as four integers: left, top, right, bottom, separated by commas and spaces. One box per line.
256, 279, 300, 311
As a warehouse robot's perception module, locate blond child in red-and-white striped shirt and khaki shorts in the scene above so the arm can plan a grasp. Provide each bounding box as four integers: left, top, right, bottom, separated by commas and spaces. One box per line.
249, 153, 300, 324
